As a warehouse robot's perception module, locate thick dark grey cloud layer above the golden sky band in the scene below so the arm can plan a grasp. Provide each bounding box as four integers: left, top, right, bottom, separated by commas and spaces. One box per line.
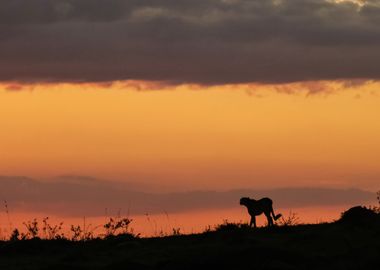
0, 0, 380, 84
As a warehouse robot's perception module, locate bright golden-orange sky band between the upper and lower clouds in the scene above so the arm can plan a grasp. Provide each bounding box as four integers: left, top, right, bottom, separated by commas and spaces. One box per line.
0, 82, 380, 189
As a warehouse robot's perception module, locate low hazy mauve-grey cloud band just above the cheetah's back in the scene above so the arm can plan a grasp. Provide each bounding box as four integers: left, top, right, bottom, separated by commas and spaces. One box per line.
0, 176, 376, 216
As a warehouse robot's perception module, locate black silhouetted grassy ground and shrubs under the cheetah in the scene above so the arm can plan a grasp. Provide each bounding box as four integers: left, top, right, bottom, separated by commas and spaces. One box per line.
0, 208, 380, 270
